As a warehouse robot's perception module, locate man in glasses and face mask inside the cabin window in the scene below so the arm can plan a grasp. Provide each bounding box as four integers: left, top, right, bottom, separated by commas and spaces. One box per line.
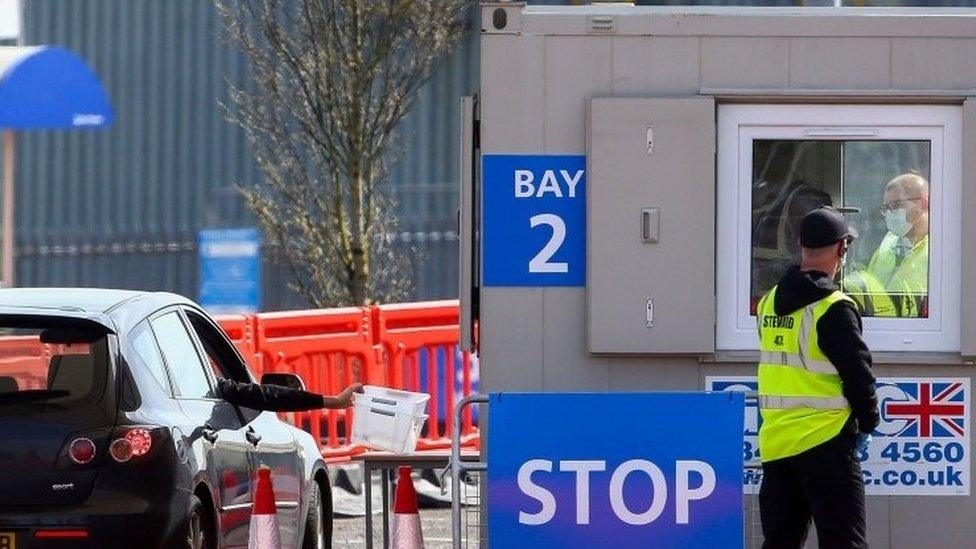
868, 173, 929, 317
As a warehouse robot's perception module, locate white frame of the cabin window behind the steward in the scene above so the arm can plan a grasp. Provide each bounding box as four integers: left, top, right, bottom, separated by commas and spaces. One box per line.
715, 104, 962, 352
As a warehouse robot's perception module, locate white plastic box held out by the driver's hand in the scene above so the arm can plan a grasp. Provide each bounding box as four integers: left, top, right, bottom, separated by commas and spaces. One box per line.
351, 385, 430, 454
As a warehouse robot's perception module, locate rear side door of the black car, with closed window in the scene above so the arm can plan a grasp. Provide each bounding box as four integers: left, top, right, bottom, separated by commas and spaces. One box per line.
150, 309, 254, 547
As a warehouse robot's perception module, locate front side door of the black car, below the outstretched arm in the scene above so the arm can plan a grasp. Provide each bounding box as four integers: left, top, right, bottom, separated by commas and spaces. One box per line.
185, 308, 305, 547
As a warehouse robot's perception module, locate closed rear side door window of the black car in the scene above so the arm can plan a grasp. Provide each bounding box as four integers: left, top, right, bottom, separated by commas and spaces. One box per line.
150, 312, 211, 398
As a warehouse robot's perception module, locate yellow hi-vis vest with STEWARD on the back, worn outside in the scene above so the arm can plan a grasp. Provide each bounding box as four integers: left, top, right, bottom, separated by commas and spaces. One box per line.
757, 287, 851, 462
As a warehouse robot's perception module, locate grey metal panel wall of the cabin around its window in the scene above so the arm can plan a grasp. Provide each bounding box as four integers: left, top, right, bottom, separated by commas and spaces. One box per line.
480, 3, 976, 547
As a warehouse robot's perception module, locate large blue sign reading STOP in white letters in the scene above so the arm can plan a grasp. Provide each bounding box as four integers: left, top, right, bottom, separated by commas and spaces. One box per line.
487, 393, 744, 549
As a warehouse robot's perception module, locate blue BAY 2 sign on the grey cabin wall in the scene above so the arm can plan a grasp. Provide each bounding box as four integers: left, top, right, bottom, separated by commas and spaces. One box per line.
482, 154, 586, 286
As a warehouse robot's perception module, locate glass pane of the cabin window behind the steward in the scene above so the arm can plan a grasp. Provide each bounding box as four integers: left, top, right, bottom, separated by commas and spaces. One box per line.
750, 139, 931, 318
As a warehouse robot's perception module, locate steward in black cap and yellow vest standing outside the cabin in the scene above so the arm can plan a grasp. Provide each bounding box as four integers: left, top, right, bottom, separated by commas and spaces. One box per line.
757, 207, 879, 549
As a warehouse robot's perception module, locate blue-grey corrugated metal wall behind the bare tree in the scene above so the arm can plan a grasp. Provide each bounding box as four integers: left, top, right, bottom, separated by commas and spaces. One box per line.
16, 0, 478, 309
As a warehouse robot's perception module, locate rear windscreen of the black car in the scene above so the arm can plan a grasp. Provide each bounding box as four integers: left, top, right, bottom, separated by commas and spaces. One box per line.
0, 317, 109, 414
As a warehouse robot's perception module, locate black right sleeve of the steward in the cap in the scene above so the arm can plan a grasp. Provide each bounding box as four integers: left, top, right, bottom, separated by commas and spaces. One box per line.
817, 302, 879, 433
